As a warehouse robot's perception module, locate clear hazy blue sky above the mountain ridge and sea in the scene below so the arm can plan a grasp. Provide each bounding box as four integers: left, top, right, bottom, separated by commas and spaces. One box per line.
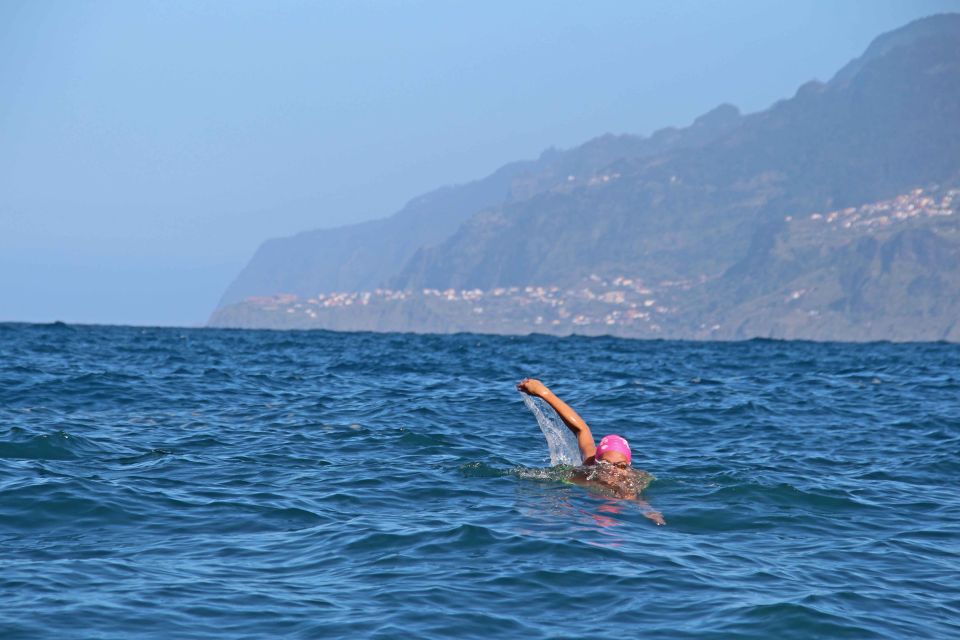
0, 0, 960, 325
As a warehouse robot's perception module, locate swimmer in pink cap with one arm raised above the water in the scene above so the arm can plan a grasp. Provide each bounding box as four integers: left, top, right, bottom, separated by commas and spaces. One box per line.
517, 378, 666, 524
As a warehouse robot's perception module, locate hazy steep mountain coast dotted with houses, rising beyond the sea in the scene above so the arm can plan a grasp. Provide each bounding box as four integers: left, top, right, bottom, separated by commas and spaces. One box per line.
212, 14, 960, 339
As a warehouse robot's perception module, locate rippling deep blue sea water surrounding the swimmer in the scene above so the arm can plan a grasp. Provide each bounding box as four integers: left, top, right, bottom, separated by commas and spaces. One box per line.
0, 324, 960, 639
